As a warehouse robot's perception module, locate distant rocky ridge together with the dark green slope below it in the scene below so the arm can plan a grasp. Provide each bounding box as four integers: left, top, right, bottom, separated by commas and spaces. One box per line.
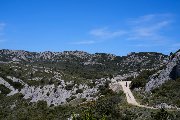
0, 49, 167, 79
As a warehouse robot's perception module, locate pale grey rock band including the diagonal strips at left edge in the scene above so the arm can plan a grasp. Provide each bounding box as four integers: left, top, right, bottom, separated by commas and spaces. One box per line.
0, 76, 106, 106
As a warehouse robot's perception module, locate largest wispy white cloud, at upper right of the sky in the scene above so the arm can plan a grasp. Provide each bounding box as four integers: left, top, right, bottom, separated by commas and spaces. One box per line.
127, 14, 172, 41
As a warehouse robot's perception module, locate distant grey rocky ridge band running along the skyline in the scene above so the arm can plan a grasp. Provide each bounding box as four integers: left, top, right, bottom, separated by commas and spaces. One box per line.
0, 49, 167, 74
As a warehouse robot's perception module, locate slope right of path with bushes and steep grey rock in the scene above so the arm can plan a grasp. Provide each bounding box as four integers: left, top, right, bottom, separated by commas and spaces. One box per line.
131, 51, 180, 108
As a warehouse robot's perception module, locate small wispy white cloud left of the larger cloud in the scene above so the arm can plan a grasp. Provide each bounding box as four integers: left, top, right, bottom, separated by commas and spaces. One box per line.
89, 27, 126, 39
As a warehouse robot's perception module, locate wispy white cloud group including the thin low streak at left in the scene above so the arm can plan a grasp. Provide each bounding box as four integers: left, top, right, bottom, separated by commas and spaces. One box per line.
73, 13, 174, 47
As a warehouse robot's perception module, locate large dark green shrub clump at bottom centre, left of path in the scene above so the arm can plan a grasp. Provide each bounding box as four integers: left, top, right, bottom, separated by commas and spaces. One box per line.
77, 93, 122, 120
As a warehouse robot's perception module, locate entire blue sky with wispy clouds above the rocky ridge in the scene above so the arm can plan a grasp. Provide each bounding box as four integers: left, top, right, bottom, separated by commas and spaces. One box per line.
0, 0, 180, 55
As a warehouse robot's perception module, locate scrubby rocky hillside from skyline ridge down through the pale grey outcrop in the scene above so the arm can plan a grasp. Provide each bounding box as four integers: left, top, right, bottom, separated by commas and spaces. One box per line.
0, 49, 167, 106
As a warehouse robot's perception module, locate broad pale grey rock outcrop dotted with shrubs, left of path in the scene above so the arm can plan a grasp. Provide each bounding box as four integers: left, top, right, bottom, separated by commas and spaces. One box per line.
20, 84, 98, 106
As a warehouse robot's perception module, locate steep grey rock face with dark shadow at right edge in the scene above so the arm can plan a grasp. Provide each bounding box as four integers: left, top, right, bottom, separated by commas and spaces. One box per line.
145, 51, 180, 92
